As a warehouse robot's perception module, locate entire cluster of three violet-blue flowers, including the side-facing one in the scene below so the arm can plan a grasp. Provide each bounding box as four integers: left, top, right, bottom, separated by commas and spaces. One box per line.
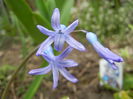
29, 8, 123, 89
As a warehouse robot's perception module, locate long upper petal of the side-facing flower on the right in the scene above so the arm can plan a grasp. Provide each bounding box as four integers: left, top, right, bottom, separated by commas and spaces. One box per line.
93, 41, 123, 62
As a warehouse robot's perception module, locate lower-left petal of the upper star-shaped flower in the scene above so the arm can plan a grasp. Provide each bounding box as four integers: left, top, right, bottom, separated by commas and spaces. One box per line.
36, 36, 53, 56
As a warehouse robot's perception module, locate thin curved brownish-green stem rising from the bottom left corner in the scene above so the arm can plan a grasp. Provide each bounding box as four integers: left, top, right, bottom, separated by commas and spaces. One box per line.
2, 47, 38, 99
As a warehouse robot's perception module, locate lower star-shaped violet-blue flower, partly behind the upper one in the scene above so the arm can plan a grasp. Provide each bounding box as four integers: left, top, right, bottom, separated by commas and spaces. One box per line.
29, 46, 78, 89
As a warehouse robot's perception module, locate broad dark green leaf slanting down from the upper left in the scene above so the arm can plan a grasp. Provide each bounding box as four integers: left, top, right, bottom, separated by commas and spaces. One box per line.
5, 0, 43, 43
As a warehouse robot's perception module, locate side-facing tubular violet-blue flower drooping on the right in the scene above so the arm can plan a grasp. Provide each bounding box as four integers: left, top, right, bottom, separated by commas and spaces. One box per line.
86, 32, 123, 69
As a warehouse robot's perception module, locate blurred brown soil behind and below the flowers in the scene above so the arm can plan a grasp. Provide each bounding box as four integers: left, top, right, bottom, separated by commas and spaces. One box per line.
0, 37, 118, 99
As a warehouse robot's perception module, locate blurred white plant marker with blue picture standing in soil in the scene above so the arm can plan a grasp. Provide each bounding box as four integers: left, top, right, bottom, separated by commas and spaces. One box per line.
99, 59, 123, 89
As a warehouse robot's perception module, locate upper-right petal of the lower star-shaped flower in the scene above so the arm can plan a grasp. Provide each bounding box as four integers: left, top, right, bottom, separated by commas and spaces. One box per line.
56, 46, 73, 60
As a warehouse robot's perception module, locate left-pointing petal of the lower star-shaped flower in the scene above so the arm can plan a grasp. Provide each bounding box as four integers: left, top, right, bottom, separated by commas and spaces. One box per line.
29, 65, 51, 75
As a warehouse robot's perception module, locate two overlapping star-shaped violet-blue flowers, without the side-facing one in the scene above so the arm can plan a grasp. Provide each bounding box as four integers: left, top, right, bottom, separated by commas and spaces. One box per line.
29, 8, 85, 89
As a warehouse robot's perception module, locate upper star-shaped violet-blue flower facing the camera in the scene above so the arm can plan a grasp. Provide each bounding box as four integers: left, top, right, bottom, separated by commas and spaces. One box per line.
36, 8, 85, 56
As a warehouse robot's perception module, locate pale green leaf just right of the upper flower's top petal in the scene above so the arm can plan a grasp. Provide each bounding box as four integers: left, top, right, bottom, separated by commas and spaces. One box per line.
61, 0, 74, 25
